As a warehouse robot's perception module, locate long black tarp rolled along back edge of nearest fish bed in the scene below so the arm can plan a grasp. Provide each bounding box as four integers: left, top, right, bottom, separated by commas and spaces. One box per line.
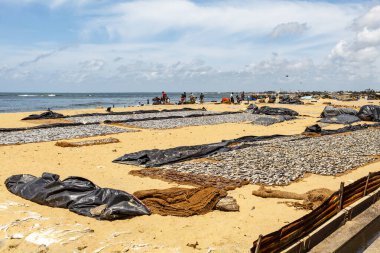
113, 135, 283, 167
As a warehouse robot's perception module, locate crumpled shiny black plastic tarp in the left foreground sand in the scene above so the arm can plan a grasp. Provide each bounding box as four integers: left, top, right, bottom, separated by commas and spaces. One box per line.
5, 172, 150, 220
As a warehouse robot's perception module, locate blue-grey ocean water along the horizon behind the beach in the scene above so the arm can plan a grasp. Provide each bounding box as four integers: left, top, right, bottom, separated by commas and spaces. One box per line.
0, 92, 230, 113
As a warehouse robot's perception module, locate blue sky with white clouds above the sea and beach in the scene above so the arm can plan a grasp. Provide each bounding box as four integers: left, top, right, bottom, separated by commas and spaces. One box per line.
0, 0, 380, 92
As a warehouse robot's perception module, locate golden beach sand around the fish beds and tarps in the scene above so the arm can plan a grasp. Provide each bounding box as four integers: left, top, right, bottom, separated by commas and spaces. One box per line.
0, 100, 380, 252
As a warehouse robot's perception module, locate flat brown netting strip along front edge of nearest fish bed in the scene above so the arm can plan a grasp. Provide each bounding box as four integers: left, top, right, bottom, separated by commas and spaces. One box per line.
129, 168, 249, 191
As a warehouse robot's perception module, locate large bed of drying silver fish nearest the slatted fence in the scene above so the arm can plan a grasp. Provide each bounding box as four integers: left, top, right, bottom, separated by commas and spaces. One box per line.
161, 128, 380, 185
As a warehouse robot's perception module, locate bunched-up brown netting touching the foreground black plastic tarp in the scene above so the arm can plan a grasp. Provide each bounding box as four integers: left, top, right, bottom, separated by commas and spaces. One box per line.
133, 187, 227, 217
